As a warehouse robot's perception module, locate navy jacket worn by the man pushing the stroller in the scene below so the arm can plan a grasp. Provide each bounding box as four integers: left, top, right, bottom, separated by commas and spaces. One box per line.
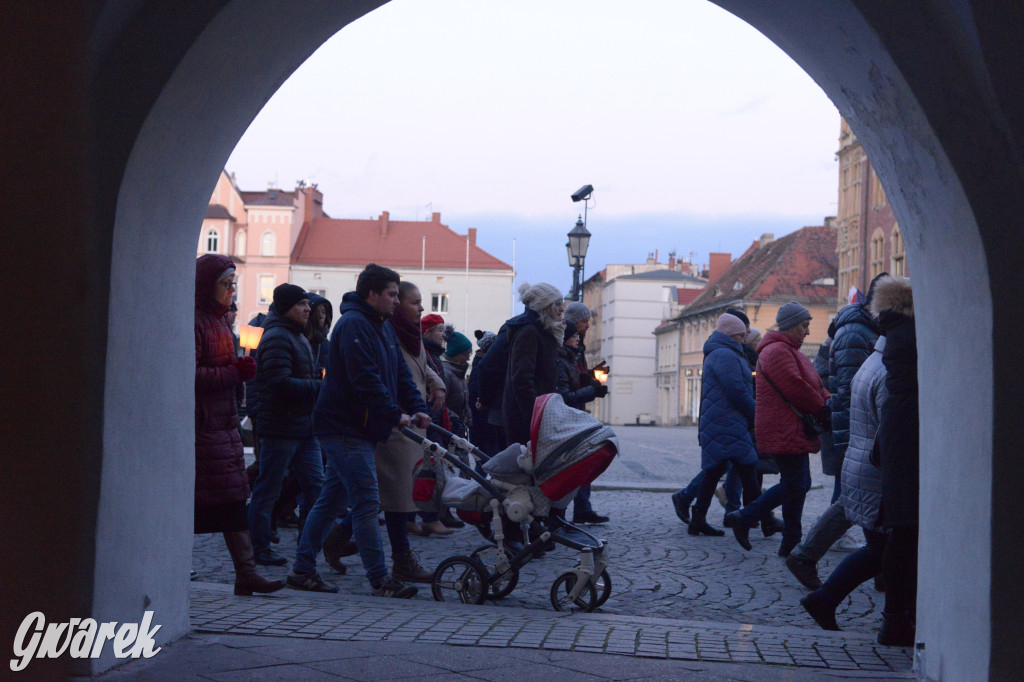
313, 291, 427, 443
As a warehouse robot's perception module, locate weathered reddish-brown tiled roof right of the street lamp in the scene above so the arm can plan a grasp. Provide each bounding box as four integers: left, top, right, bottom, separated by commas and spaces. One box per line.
683, 225, 839, 316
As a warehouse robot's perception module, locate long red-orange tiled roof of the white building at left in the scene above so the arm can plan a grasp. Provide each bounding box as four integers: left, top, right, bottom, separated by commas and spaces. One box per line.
292, 214, 512, 270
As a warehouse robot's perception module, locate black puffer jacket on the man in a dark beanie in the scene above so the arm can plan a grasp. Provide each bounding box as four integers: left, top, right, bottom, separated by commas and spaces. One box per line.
256, 305, 321, 438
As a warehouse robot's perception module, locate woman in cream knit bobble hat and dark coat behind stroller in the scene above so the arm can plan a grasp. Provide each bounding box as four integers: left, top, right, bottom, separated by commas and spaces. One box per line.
502, 283, 565, 444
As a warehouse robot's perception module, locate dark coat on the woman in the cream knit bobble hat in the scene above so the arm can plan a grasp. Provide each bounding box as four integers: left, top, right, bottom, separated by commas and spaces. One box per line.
502, 310, 560, 444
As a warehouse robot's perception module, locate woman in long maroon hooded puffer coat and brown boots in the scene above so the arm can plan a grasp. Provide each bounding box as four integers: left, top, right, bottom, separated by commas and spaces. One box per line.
195, 254, 285, 595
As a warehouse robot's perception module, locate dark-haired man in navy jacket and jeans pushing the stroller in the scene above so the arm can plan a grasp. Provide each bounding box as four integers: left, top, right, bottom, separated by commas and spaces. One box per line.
288, 263, 430, 599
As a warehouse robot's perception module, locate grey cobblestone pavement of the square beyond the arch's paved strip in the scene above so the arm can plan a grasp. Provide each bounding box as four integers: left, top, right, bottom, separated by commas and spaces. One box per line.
193, 427, 909, 670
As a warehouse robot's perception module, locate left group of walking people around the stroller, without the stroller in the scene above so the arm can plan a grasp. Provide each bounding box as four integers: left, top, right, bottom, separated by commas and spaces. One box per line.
195, 254, 608, 598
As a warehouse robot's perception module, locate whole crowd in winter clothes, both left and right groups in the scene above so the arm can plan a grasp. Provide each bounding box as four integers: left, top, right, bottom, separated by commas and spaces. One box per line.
195, 254, 918, 645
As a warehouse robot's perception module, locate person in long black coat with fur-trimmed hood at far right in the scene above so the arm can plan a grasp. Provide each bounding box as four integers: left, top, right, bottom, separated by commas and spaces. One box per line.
871, 276, 921, 646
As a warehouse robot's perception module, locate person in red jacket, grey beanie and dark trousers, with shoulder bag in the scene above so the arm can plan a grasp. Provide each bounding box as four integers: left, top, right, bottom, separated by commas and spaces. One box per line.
725, 301, 828, 556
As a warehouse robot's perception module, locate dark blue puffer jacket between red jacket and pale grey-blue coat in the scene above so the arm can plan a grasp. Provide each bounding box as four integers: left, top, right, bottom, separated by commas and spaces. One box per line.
828, 303, 881, 450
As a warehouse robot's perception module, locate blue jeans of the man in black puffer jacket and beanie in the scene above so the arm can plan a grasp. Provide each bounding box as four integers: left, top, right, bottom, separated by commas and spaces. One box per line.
249, 436, 324, 554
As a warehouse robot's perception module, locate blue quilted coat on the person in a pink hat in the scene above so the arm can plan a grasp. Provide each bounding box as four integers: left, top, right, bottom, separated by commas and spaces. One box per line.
700, 332, 758, 469
